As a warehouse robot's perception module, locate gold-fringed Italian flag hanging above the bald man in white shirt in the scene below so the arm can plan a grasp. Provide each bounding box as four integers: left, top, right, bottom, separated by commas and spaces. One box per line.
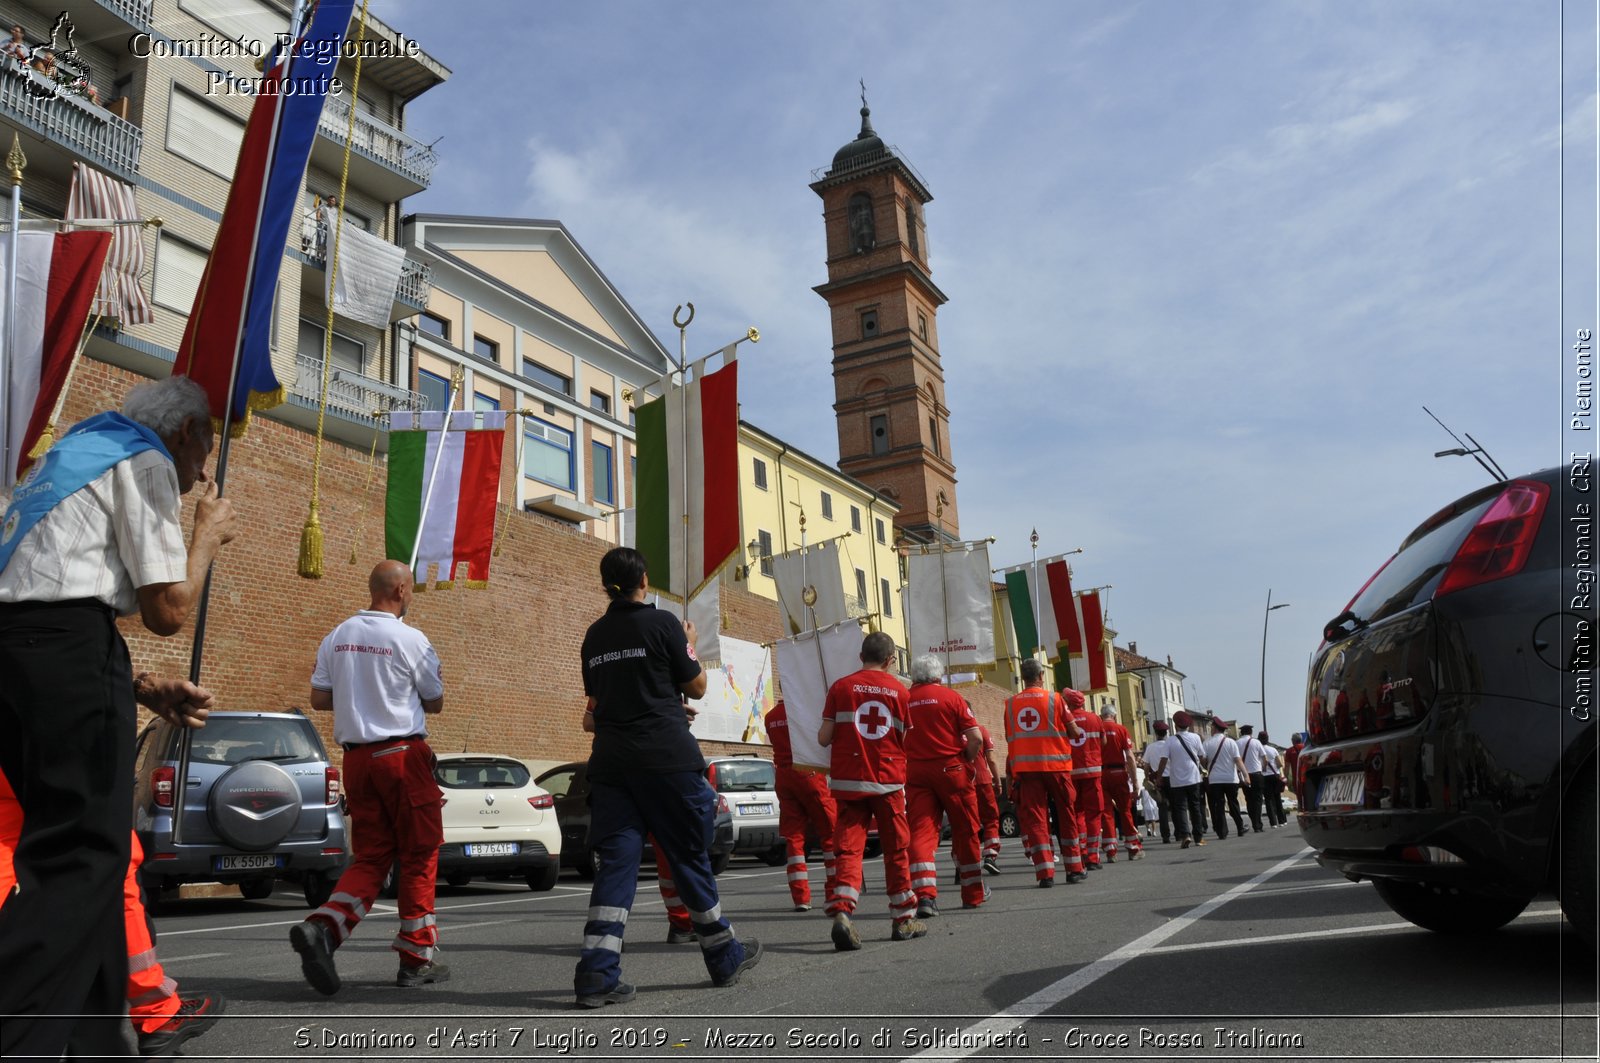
384, 410, 506, 588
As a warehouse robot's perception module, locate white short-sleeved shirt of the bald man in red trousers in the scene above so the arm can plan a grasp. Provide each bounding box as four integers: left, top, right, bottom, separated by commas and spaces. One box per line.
310, 608, 445, 744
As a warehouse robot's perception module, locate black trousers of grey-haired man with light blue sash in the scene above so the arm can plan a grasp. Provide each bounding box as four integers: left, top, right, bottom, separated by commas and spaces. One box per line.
0, 602, 134, 1060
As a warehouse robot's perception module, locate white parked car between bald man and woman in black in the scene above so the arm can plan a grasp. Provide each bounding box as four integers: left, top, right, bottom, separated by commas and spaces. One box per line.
434, 752, 562, 890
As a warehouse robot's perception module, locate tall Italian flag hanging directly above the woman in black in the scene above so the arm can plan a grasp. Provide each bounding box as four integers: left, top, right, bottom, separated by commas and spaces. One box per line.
634, 347, 739, 602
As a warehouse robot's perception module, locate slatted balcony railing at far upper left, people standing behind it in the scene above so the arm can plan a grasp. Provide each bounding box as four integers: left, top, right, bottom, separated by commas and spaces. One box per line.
0, 61, 144, 182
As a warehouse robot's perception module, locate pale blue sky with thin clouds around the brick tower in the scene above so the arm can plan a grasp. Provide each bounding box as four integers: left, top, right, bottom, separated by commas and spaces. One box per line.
373, 0, 1595, 738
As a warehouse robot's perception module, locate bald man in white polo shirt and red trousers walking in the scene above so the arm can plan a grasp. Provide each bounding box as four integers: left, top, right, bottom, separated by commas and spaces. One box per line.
290, 560, 450, 996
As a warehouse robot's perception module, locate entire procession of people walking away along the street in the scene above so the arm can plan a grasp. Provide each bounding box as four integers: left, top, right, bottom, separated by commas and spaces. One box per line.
0, 376, 1298, 1058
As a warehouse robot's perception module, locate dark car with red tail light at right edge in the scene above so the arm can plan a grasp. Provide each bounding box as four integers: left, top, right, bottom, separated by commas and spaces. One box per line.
1294, 463, 1597, 943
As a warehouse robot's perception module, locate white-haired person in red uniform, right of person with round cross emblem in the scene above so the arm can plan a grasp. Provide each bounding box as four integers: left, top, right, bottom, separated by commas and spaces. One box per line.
906, 653, 989, 919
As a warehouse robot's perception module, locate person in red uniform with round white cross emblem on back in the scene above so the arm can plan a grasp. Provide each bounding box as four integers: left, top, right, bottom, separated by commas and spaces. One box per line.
816, 631, 928, 951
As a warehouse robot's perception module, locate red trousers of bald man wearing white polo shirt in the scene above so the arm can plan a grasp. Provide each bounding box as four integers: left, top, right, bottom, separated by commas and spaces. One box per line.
307, 738, 445, 967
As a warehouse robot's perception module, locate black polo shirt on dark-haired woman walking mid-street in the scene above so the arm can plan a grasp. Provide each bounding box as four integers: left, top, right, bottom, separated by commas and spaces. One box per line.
582, 602, 706, 783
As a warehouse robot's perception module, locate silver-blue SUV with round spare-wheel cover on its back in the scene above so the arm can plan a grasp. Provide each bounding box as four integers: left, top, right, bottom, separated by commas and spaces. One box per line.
133, 712, 349, 908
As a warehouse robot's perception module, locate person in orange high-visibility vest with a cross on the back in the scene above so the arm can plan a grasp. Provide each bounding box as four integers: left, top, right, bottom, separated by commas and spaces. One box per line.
1005, 658, 1088, 887
